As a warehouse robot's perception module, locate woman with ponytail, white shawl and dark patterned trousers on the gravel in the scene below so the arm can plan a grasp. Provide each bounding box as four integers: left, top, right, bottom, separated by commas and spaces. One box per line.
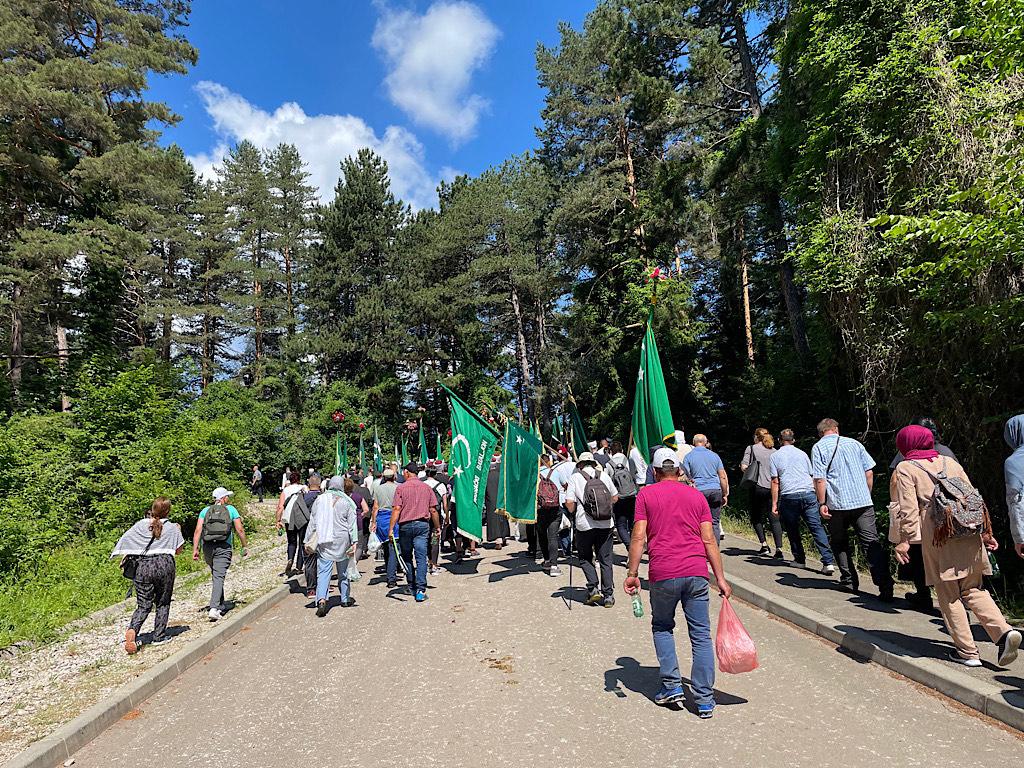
112, 497, 185, 653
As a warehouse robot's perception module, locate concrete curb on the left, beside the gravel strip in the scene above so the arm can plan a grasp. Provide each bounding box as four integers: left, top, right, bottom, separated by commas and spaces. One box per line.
4, 585, 291, 768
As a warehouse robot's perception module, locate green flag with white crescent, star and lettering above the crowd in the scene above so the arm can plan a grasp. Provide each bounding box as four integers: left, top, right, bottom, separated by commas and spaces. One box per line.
441, 384, 498, 542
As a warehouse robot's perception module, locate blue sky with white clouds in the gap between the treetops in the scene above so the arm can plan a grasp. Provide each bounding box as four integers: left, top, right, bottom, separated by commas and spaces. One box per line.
151, 0, 593, 206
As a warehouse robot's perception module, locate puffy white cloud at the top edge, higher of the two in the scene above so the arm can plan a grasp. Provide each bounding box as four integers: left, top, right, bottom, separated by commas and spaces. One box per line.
373, 0, 501, 143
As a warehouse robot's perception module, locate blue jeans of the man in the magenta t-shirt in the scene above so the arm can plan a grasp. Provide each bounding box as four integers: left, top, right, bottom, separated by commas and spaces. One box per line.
650, 577, 715, 706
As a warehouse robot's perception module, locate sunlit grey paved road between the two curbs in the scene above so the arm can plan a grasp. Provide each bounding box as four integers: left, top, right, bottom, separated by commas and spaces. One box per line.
68, 545, 1024, 768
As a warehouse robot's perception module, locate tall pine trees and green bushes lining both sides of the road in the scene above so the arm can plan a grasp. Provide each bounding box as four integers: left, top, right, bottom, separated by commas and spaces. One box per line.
0, 0, 1024, 643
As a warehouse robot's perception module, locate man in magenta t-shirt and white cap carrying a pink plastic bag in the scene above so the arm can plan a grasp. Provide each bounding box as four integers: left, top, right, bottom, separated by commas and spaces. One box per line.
625, 447, 732, 719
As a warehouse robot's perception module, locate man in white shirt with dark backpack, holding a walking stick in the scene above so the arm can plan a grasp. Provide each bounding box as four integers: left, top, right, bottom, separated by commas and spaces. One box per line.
565, 452, 618, 608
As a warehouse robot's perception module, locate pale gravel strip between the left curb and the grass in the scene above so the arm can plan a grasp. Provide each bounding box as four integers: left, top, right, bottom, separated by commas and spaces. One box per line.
0, 502, 286, 766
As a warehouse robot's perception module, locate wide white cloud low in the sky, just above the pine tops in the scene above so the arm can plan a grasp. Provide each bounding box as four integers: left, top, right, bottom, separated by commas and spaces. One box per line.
188, 81, 438, 208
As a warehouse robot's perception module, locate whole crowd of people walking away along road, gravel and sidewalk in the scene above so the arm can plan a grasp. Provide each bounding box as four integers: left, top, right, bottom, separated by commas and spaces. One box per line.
105, 415, 1024, 717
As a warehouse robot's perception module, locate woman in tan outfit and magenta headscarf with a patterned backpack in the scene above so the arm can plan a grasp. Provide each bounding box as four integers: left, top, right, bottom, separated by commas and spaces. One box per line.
889, 426, 1022, 667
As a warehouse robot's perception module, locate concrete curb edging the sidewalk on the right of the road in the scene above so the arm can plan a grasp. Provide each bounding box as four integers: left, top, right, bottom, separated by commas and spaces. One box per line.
728, 575, 1024, 731
